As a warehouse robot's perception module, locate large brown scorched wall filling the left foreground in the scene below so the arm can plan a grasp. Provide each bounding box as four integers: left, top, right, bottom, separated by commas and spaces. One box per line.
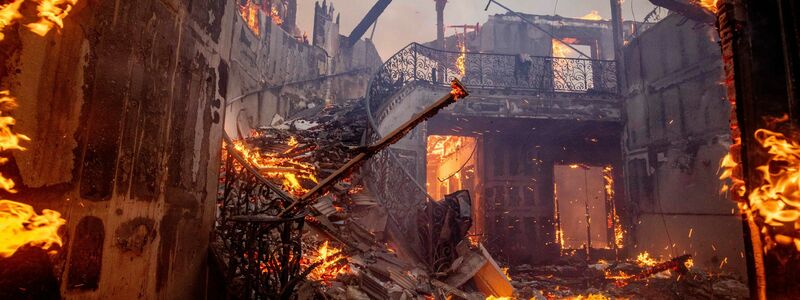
0, 0, 244, 299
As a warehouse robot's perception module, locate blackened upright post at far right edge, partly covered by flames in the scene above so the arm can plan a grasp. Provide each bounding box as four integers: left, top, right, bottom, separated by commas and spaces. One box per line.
717, 0, 800, 299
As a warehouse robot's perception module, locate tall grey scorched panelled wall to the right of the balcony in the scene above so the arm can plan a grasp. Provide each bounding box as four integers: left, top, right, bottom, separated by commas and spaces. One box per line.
623, 15, 745, 274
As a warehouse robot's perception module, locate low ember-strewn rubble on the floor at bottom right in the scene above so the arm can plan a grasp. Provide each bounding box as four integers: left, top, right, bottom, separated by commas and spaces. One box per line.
509, 257, 749, 299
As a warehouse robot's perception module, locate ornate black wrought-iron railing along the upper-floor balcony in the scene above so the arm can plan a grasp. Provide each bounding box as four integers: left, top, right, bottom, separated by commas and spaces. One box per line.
368, 43, 617, 112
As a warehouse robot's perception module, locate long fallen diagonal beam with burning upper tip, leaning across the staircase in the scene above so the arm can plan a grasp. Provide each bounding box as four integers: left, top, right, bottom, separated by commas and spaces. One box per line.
278, 78, 469, 217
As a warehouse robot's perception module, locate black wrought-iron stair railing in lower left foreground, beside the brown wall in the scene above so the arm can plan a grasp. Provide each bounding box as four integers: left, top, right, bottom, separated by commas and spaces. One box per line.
214, 133, 308, 299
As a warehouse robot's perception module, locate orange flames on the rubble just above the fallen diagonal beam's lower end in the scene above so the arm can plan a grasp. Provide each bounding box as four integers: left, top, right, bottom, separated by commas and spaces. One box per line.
233, 137, 318, 196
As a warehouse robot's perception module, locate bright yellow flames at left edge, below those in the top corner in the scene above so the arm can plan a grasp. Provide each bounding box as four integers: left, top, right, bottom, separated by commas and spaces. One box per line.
0, 91, 66, 257
